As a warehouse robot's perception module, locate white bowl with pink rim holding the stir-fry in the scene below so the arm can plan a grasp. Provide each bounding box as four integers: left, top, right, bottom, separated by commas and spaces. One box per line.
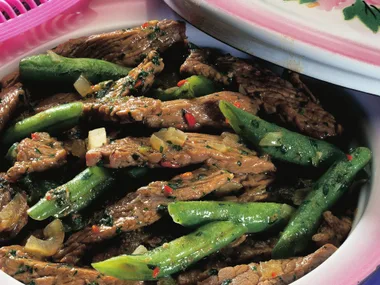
0, 0, 380, 285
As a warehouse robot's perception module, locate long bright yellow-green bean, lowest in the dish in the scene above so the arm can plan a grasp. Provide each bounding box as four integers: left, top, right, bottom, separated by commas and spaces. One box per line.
92, 221, 247, 280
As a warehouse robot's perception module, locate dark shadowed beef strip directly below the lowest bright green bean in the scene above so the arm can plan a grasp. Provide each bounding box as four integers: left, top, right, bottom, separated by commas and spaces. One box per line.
176, 236, 277, 285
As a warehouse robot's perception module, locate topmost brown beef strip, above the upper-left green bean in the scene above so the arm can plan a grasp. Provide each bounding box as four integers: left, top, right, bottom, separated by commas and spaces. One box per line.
54, 20, 186, 67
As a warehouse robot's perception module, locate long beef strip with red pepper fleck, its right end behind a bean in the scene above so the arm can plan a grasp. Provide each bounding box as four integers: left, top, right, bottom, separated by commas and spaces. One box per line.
84, 91, 257, 127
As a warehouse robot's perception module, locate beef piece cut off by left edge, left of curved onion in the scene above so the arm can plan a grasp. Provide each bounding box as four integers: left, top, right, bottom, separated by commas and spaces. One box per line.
0, 179, 29, 242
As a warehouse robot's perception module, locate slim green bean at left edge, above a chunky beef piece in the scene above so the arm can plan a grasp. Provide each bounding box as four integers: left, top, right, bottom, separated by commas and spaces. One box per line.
2, 102, 83, 144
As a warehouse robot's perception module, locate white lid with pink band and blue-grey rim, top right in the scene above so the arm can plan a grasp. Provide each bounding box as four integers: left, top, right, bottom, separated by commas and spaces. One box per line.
165, 0, 380, 95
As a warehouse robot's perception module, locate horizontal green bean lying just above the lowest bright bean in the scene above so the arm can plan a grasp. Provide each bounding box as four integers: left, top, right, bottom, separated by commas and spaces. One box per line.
168, 201, 294, 233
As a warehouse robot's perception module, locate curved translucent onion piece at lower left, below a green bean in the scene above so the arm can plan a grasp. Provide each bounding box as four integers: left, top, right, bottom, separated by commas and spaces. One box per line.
25, 219, 65, 256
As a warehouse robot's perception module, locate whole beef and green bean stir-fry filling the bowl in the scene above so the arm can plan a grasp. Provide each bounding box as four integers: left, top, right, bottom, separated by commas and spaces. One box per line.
0, 20, 371, 285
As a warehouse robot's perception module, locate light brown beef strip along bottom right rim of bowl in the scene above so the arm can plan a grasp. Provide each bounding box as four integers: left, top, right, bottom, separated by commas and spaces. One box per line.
200, 244, 336, 285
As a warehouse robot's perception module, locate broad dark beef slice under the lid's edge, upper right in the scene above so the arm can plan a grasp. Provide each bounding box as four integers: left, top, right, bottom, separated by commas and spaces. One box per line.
218, 56, 342, 139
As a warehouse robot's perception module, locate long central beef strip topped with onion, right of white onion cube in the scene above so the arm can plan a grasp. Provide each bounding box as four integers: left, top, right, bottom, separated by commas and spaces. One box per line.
86, 130, 275, 174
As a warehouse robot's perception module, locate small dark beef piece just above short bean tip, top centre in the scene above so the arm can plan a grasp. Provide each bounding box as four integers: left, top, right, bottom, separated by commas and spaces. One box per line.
180, 48, 232, 85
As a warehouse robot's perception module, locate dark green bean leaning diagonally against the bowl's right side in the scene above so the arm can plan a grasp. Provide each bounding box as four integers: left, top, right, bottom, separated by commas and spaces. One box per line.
272, 147, 371, 258
